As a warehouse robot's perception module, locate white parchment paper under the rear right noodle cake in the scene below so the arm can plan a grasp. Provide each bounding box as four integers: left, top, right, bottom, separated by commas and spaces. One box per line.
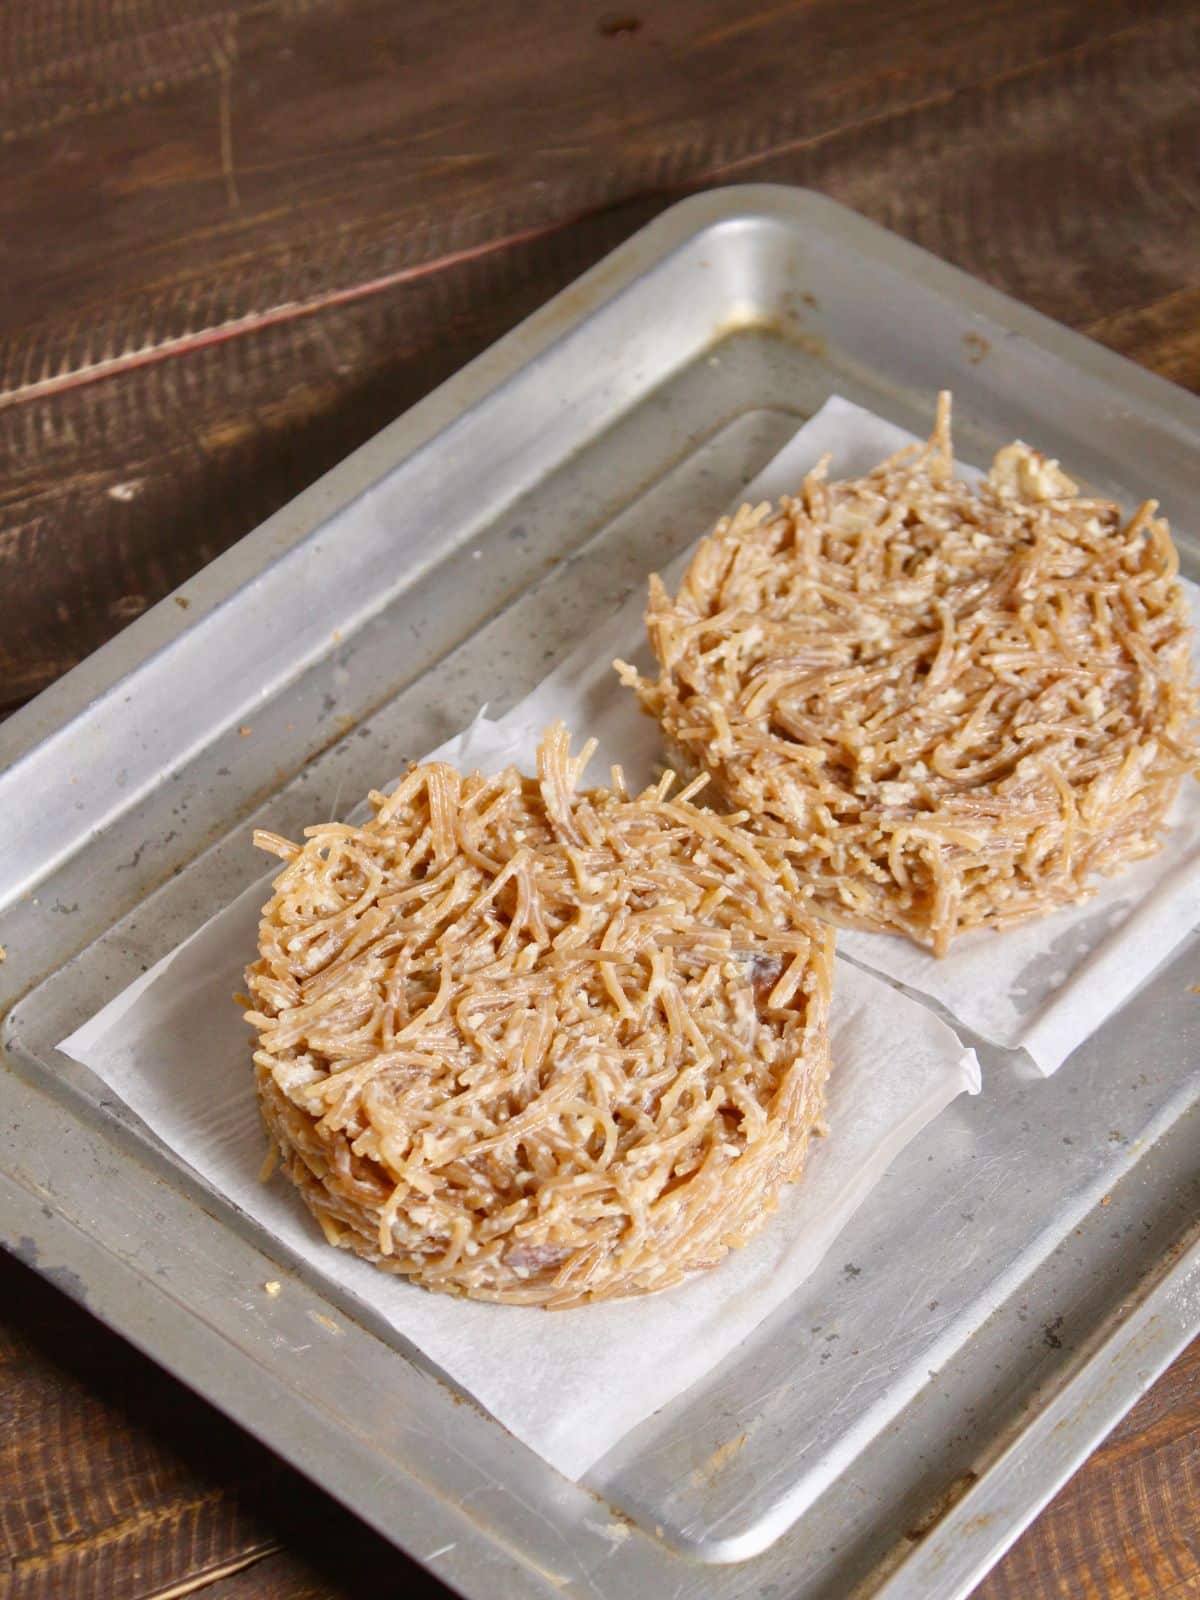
489, 397, 1200, 1074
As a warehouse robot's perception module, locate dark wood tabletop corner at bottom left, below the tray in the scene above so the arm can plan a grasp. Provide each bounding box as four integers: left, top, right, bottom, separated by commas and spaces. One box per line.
0, 1251, 446, 1600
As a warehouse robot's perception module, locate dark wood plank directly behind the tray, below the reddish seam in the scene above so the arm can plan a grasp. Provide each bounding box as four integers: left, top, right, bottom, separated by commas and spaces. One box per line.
0, 4, 1200, 706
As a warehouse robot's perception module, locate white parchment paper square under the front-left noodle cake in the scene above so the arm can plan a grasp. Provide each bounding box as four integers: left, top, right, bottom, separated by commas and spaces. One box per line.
59, 681, 979, 1477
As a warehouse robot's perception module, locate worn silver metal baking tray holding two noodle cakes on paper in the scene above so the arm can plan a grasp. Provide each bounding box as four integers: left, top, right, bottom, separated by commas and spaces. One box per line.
0, 187, 1200, 1600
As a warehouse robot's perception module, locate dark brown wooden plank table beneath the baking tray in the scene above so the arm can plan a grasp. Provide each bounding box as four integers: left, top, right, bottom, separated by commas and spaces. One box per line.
0, 0, 1200, 1600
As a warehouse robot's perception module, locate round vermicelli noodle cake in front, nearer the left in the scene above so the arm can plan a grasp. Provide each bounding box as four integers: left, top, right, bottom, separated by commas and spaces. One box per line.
246, 726, 834, 1307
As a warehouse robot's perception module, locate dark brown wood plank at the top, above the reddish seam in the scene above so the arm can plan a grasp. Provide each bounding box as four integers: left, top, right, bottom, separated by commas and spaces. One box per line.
0, 0, 1192, 397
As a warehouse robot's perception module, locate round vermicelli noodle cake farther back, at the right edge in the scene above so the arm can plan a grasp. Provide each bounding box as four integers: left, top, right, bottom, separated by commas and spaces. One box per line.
618, 395, 1197, 955
